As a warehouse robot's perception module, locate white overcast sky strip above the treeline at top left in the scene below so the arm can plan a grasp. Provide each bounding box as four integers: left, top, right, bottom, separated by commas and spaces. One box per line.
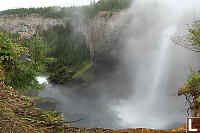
0, 0, 98, 11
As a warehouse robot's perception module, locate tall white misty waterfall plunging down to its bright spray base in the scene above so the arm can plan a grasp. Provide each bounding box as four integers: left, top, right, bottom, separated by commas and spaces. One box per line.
114, 0, 200, 129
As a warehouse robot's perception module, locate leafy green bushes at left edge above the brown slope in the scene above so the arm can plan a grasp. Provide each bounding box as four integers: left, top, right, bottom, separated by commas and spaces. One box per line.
0, 30, 47, 91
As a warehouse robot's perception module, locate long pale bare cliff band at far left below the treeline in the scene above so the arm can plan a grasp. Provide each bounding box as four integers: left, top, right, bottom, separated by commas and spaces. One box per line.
0, 14, 65, 37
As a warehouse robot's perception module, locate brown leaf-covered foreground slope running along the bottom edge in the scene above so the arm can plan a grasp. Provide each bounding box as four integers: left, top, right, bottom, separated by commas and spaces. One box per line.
0, 82, 185, 133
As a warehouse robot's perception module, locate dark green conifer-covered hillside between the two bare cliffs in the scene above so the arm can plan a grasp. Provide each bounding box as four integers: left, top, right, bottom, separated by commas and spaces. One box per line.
41, 24, 90, 84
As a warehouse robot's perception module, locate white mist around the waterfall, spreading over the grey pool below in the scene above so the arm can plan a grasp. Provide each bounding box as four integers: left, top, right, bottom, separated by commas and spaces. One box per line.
40, 0, 200, 129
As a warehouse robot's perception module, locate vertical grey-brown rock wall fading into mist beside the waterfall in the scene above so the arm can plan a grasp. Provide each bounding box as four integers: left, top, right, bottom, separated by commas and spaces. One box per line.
80, 12, 119, 61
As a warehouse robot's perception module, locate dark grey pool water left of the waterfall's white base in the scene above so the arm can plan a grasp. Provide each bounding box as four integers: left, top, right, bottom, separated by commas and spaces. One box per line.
39, 80, 123, 128
